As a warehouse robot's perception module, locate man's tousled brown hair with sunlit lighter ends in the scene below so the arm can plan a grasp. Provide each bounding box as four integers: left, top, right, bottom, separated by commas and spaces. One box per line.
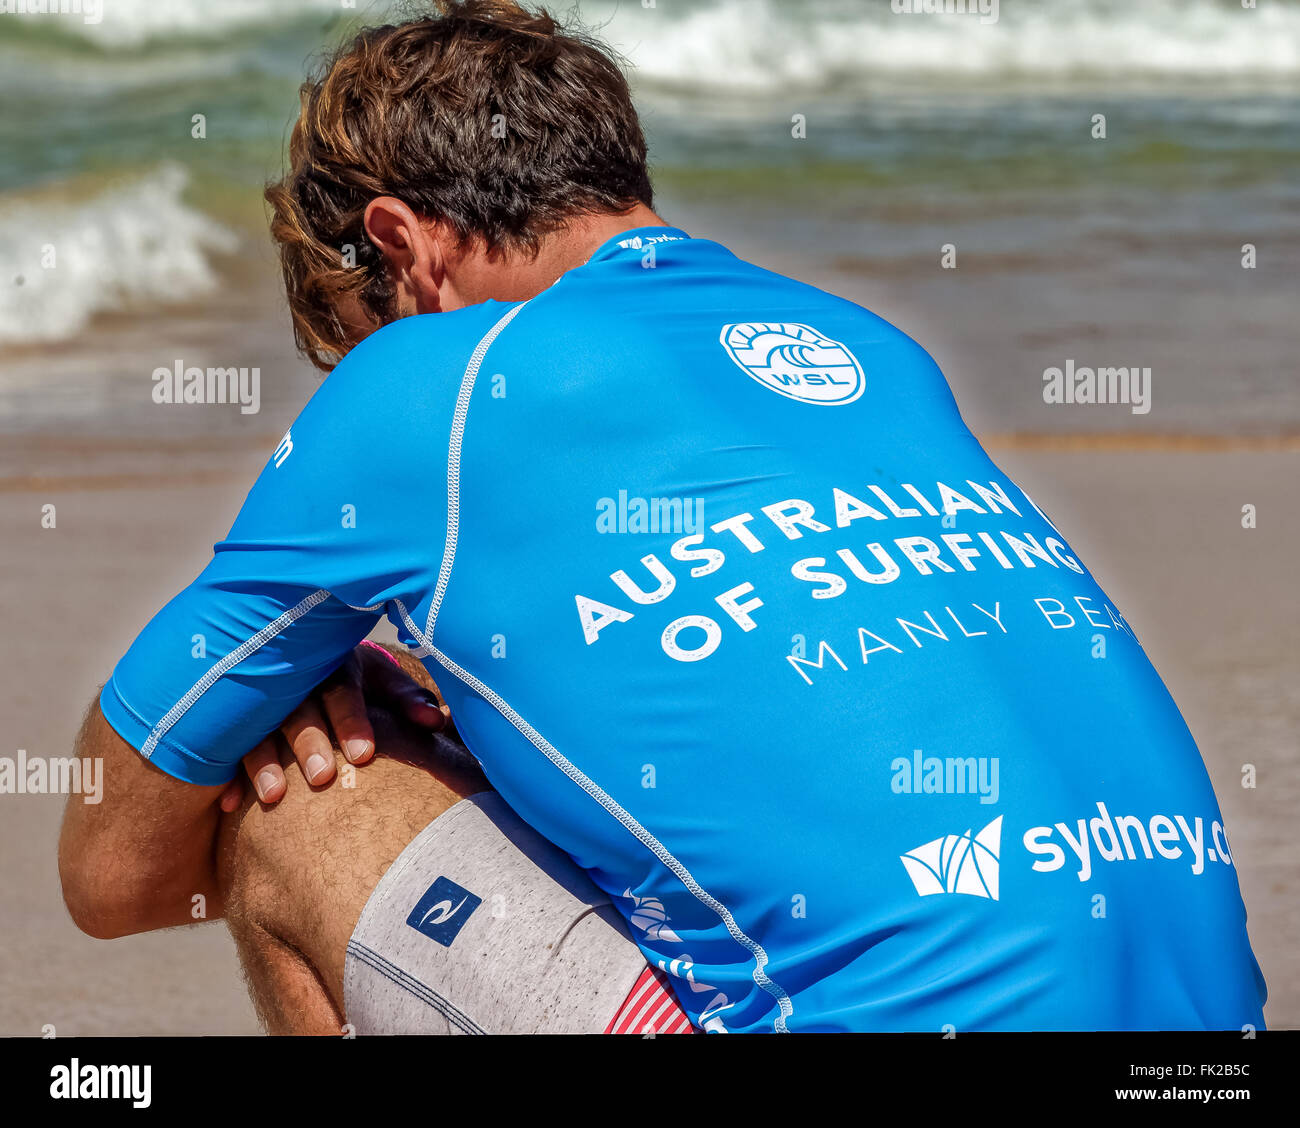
265, 0, 653, 372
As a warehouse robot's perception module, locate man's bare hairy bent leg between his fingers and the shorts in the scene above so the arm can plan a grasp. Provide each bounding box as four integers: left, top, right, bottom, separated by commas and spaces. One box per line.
218, 710, 490, 1034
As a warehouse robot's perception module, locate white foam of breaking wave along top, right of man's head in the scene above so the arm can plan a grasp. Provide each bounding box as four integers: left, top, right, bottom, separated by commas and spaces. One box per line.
582, 0, 1300, 90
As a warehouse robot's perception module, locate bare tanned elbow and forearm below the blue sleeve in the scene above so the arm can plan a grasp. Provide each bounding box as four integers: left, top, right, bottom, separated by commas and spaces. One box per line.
59, 700, 225, 940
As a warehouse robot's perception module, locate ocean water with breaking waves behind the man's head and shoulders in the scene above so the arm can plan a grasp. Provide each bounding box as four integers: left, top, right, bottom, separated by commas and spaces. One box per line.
0, 0, 1300, 435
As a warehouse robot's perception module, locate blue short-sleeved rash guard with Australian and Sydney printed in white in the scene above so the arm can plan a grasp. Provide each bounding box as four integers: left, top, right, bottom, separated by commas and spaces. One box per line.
101, 227, 1265, 1031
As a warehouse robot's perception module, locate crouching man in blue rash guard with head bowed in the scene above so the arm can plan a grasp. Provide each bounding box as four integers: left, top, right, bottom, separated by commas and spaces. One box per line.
61, 3, 1264, 1032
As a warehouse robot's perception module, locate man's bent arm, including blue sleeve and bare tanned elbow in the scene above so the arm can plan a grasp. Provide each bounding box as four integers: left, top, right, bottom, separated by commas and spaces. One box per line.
60, 316, 482, 936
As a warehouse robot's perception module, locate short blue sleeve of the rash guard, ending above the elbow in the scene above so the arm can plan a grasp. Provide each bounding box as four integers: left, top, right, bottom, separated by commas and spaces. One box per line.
100, 314, 488, 784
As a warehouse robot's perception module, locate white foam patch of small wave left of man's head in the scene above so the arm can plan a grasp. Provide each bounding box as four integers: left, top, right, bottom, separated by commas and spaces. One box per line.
0, 165, 239, 342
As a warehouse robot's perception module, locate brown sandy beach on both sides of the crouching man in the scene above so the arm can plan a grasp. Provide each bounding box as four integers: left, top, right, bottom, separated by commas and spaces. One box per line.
0, 434, 1300, 1036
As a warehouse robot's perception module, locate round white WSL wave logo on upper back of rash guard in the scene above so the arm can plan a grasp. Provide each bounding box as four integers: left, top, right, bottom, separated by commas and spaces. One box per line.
719, 322, 866, 407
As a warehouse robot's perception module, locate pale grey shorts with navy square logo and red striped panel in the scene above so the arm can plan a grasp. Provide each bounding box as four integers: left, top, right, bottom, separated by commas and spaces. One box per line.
343, 791, 693, 1036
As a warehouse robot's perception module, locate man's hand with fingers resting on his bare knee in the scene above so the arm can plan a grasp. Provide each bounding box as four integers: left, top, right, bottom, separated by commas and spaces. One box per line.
221, 642, 450, 812
